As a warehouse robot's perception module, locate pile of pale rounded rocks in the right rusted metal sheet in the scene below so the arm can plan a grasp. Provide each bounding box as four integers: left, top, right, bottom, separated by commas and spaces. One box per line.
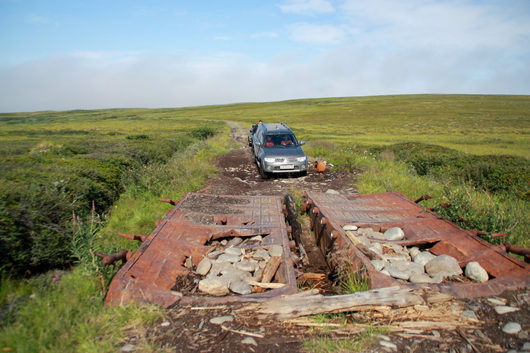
343, 225, 489, 283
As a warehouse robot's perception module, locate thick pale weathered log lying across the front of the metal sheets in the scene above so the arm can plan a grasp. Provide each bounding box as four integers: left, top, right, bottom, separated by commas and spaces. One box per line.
241, 286, 425, 319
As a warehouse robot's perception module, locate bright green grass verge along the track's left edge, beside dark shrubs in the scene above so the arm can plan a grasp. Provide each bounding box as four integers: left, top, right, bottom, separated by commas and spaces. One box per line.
0, 131, 231, 352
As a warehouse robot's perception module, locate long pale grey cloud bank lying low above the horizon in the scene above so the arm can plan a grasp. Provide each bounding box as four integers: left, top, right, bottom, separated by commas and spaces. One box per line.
0, 42, 530, 112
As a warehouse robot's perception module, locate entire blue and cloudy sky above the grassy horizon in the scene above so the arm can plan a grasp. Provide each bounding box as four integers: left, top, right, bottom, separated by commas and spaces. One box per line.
0, 0, 530, 112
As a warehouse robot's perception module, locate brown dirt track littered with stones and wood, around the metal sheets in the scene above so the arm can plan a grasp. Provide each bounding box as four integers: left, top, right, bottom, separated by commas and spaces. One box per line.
134, 122, 530, 353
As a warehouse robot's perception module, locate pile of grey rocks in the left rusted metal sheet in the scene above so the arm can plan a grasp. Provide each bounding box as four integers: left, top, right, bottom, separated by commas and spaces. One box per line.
190, 236, 283, 296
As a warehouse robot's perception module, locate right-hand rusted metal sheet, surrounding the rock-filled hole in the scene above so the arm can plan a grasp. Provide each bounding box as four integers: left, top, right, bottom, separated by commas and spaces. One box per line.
302, 192, 530, 297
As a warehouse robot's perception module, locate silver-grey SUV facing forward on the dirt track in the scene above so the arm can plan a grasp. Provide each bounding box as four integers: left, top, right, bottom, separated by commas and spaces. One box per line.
249, 124, 308, 178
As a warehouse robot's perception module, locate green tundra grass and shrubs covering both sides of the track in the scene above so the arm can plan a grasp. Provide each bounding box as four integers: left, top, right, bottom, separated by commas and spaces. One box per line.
0, 95, 530, 352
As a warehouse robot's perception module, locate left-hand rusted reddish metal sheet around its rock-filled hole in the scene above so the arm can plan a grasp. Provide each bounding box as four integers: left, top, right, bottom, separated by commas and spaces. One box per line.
105, 193, 297, 307
